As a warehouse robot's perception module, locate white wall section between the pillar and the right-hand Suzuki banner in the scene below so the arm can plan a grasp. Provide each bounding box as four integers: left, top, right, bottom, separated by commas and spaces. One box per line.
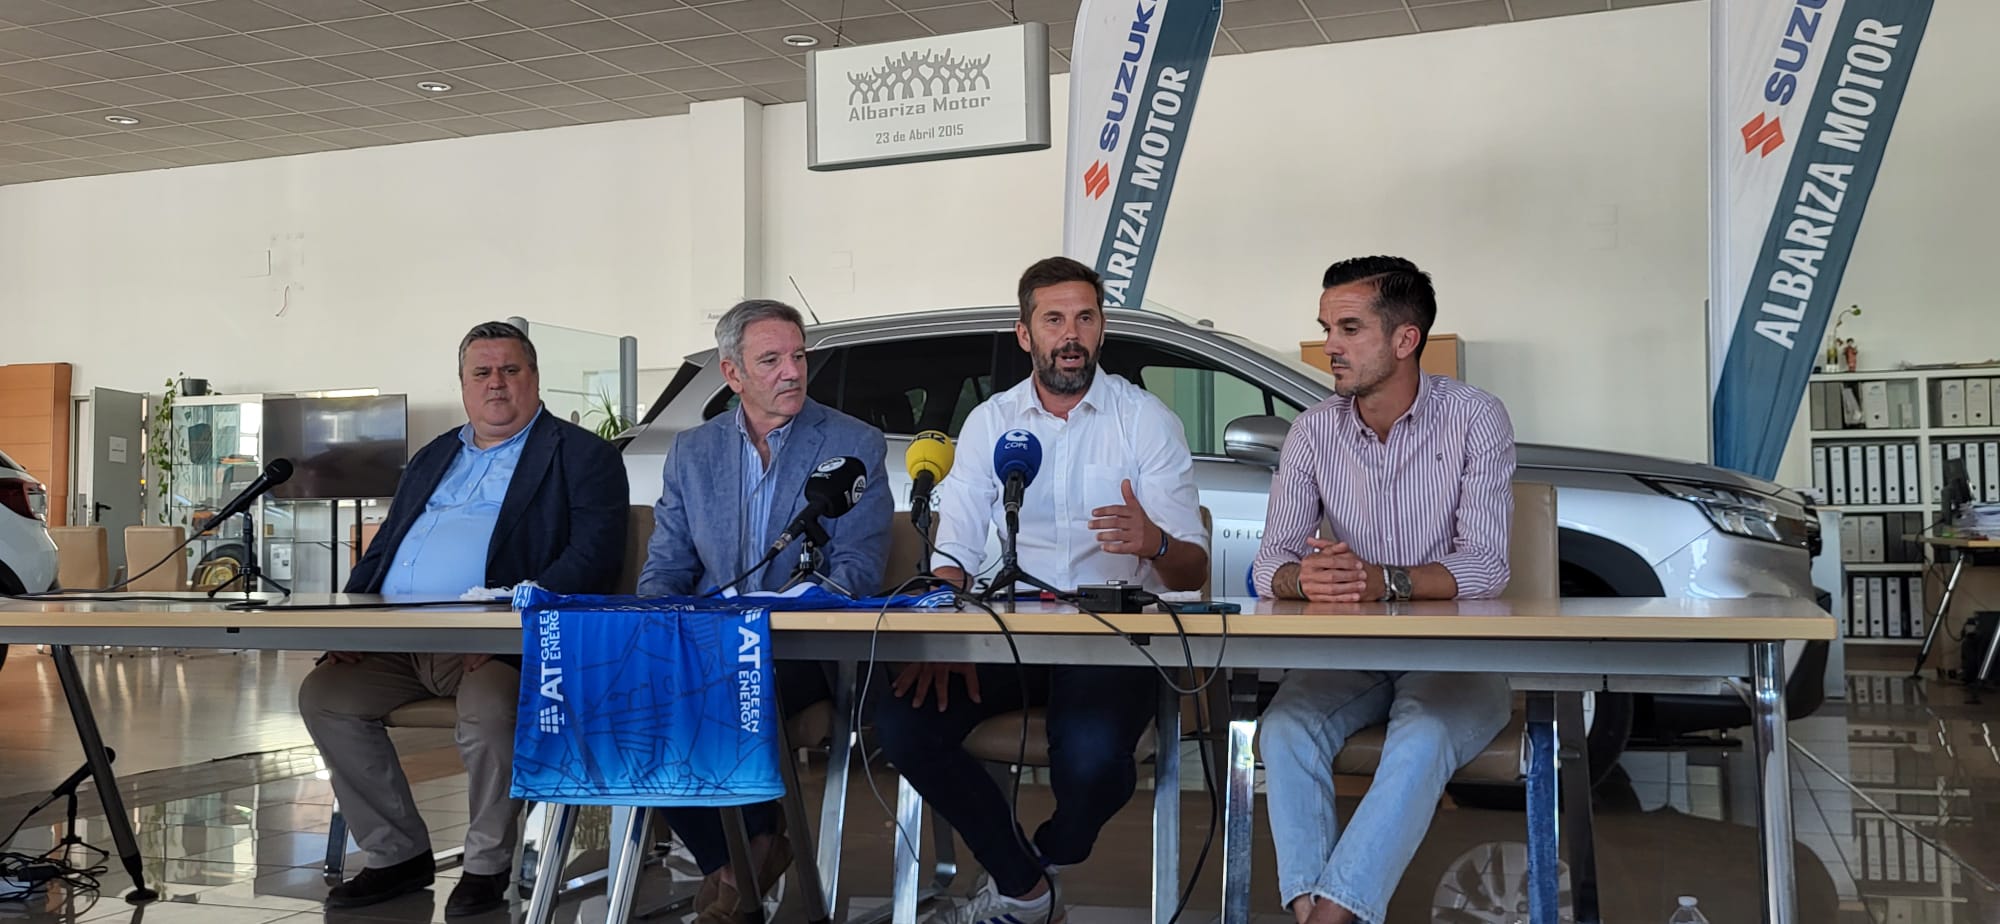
764, 4, 1706, 456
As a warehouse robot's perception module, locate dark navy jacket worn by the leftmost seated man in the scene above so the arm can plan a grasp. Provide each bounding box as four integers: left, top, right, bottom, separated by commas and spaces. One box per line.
346, 408, 630, 594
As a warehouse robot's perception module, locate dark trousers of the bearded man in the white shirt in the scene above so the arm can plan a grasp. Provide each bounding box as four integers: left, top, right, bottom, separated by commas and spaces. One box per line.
872, 664, 1160, 896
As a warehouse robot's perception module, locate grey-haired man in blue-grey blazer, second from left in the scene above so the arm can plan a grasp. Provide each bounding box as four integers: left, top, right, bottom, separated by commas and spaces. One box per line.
638, 300, 894, 924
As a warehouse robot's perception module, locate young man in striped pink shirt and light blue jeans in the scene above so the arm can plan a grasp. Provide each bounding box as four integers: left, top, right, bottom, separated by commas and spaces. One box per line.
1252, 256, 1514, 924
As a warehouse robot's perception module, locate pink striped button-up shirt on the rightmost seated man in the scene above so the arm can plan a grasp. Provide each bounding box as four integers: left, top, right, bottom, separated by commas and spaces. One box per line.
1250, 376, 1514, 600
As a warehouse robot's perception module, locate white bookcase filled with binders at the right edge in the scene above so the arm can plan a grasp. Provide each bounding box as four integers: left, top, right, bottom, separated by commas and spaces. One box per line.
1806, 366, 2000, 646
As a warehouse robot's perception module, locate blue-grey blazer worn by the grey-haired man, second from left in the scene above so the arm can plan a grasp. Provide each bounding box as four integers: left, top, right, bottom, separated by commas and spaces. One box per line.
638, 398, 896, 596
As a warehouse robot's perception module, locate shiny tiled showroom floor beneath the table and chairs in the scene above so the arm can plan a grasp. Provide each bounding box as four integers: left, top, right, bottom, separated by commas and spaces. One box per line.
0, 648, 2000, 924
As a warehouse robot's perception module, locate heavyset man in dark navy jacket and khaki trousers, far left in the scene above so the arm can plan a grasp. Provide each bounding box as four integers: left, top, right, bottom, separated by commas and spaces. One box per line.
298, 322, 628, 916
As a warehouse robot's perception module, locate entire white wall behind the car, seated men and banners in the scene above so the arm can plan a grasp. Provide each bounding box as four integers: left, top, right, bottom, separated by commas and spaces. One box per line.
0, 0, 2000, 472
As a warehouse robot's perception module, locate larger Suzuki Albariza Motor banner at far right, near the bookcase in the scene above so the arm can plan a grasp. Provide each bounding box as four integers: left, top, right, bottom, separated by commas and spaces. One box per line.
1708, 0, 1930, 478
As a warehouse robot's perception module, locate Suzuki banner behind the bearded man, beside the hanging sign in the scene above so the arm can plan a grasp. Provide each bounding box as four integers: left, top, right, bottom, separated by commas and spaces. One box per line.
1062, 0, 1222, 308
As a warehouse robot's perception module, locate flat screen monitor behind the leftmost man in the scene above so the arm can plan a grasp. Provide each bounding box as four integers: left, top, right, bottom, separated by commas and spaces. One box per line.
264, 394, 410, 500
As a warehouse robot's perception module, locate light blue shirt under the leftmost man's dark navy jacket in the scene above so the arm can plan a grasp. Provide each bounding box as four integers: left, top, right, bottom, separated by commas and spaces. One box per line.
382, 410, 542, 596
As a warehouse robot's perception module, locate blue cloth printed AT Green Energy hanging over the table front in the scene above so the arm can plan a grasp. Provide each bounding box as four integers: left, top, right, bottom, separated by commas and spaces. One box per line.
512, 596, 784, 806
